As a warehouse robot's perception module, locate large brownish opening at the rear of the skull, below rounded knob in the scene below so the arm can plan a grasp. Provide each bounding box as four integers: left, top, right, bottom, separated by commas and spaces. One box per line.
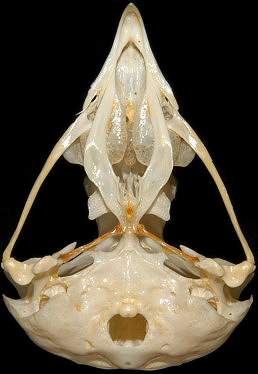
108, 313, 148, 345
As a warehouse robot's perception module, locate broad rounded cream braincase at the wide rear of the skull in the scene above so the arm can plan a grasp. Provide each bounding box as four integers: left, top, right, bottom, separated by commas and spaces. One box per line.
4, 237, 252, 370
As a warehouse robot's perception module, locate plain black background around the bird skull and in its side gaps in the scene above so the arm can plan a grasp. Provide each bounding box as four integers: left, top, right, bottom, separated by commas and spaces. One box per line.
0, 0, 258, 373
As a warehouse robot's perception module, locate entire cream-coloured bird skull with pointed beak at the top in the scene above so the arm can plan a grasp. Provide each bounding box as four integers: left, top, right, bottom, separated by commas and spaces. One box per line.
2, 4, 255, 370
